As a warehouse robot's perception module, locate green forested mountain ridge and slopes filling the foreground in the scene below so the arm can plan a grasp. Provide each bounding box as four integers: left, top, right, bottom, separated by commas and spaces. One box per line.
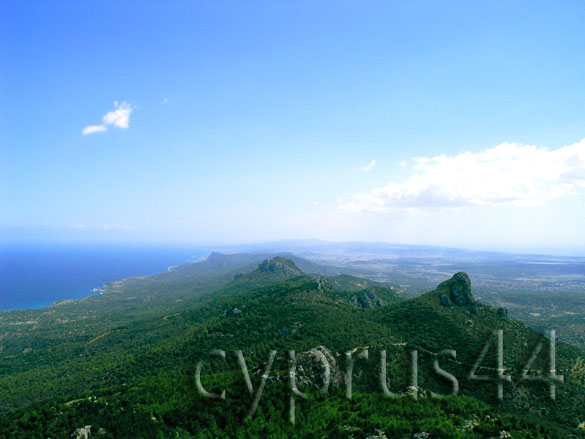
0, 254, 585, 438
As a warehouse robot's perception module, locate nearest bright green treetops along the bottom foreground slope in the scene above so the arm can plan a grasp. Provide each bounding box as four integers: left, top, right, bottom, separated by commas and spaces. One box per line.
0, 377, 566, 439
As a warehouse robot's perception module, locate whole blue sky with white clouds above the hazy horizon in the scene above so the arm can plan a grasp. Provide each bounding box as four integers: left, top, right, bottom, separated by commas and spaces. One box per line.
0, 1, 585, 254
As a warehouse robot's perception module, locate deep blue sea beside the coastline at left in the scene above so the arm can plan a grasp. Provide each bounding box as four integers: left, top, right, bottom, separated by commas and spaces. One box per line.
0, 244, 209, 310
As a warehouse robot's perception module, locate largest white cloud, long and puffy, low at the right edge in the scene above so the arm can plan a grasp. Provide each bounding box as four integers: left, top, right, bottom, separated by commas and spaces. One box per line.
341, 139, 585, 212
